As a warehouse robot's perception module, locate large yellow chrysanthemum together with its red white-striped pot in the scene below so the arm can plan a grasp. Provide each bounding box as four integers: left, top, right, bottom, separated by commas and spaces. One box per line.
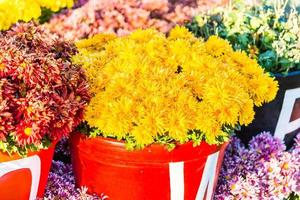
71, 27, 278, 200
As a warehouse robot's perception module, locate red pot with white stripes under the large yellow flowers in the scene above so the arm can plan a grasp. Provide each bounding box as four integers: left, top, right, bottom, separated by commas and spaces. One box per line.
71, 133, 227, 200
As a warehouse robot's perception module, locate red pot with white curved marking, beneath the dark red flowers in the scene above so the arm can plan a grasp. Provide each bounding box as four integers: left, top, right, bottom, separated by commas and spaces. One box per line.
0, 143, 56, 200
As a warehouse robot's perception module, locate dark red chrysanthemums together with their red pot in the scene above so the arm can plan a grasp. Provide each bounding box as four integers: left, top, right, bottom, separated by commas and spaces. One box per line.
0, 23, 89, 200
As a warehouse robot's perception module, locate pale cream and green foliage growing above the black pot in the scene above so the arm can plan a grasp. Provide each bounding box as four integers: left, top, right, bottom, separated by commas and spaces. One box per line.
187, 0, 300, 74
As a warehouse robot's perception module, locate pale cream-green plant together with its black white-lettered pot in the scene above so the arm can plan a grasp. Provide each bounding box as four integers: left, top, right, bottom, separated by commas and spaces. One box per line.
187, 0, 300, 145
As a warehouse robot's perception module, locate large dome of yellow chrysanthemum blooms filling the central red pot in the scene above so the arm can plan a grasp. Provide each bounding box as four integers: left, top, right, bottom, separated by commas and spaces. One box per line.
73, 27, 278, 148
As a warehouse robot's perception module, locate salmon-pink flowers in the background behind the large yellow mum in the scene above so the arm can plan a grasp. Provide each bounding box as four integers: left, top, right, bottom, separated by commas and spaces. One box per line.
47, 0, 224, 40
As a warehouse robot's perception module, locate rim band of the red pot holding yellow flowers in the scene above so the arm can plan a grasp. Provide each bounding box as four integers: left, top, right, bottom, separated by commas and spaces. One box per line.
70, 132, 228, 164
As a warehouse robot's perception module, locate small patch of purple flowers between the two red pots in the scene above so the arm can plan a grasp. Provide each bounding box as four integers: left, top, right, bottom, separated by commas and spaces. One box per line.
44, 161, 107, 200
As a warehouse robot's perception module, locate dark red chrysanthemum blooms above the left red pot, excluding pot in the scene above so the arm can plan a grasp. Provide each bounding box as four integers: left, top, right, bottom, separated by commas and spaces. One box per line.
0, 23, 89, 155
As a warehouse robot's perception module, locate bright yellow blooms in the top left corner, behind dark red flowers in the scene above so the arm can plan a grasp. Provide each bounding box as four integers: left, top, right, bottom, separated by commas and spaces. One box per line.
0, 0, 73, 30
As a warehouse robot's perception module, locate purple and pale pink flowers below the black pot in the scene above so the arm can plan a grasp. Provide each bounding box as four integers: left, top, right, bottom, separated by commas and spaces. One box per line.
215, 132, 300, 200
